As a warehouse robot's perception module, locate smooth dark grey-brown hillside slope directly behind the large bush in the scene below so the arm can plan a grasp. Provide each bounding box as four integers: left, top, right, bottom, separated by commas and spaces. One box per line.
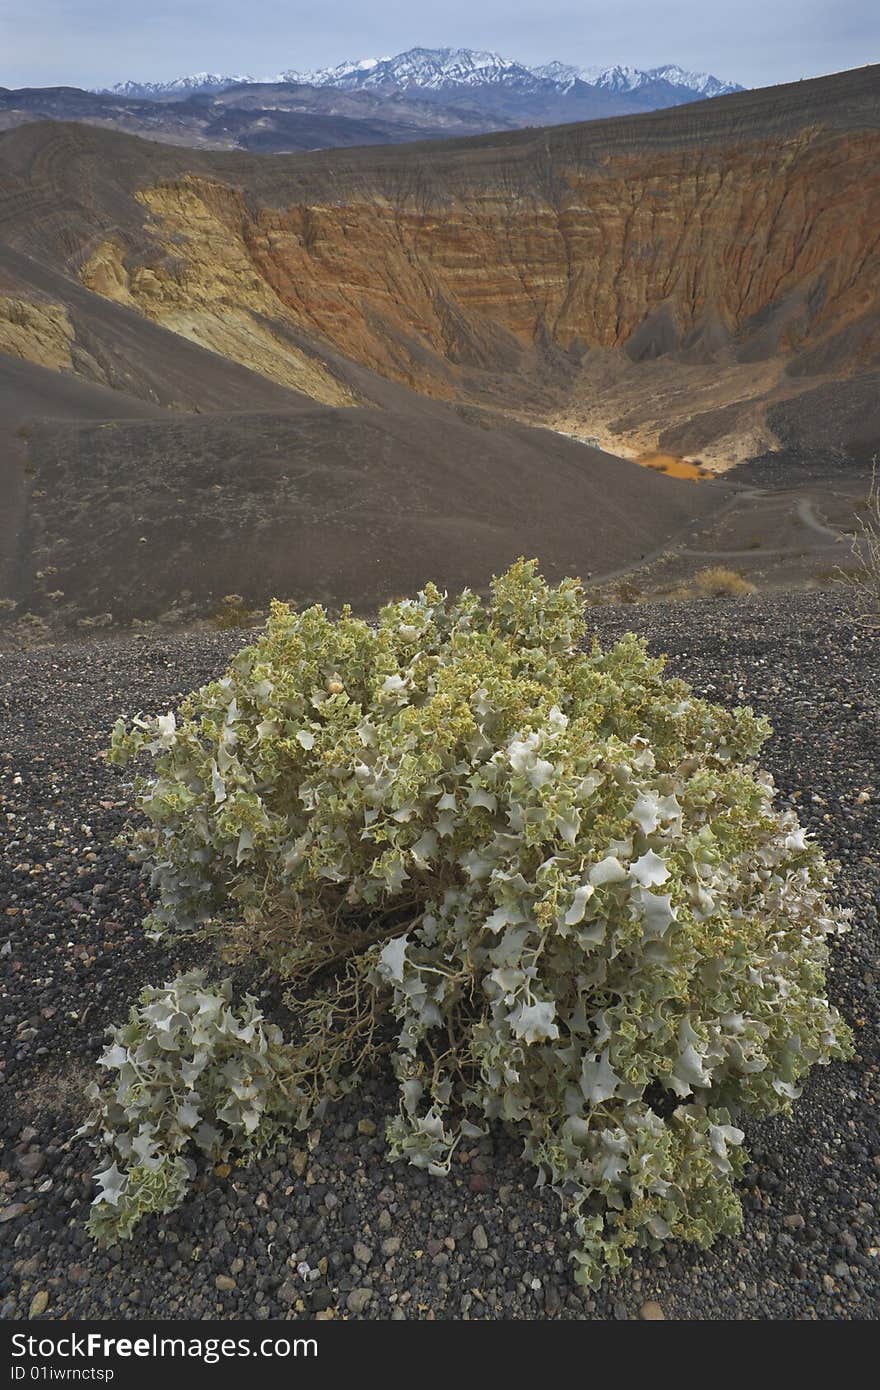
0, 347, 717, 626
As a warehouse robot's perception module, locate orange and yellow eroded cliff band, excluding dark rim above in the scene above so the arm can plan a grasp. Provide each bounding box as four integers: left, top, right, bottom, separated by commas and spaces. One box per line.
75, 121, 880, 444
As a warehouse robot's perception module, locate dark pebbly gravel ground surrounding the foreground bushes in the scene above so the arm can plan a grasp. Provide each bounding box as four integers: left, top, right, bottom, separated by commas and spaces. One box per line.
0, 594, 880, 1319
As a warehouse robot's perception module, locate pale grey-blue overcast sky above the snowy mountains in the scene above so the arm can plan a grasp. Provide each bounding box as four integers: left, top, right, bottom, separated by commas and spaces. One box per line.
0, 0, 880, 88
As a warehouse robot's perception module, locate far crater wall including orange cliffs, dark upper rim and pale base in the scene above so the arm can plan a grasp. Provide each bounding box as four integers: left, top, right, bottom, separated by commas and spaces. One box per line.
5, 70, 880, 466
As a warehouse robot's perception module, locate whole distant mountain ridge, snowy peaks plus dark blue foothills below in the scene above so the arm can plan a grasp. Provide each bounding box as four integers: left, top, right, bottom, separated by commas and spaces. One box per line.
0, 49, 741, 154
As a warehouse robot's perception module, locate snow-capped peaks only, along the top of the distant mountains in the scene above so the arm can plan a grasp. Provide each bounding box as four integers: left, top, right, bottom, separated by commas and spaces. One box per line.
103, 49, 742, 104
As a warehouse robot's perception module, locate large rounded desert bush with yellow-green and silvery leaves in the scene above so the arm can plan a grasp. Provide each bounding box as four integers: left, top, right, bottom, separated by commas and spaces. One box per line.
104, 562, 848, 1283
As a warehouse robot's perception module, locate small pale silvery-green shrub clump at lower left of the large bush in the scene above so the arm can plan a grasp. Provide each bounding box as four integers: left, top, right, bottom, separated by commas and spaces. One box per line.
79, 970, 301, 1240
